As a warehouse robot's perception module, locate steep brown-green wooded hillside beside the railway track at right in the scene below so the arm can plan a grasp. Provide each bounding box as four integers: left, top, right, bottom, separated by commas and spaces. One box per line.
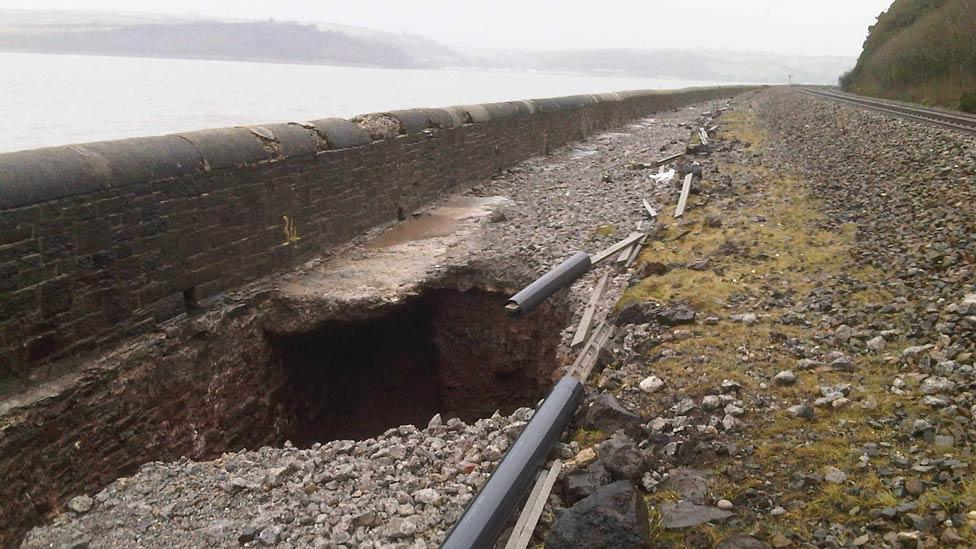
841, 0, 976, 112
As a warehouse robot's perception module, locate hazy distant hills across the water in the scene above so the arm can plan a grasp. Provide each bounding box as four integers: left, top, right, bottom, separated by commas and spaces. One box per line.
0, 9, 854, 84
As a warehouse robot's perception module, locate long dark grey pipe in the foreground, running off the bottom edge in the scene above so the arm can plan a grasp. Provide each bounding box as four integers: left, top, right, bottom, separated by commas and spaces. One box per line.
441, 376, 583, 549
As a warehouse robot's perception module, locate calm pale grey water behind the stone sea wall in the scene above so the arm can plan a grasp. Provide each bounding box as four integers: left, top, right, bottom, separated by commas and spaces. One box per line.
0, 53, 732, 152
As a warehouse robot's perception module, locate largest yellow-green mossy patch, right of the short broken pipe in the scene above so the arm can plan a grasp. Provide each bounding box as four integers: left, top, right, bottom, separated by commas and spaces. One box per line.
619, 158, 854, 315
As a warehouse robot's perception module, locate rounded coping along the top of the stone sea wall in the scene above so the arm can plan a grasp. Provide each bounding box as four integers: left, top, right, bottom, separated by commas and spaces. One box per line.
0, 86, 759, 209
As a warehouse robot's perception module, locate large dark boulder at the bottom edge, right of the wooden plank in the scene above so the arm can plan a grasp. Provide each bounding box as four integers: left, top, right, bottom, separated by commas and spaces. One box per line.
545, 480, 650, 549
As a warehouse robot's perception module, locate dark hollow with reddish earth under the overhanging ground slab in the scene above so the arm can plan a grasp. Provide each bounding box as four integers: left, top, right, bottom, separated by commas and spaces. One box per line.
270, 289, 568, 446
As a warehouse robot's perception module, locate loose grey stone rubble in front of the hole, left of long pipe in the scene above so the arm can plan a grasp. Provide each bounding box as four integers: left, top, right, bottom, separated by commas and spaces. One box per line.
23, 408, 532, 548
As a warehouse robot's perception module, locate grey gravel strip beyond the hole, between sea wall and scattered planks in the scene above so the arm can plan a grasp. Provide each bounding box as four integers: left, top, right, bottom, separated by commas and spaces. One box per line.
471, 101, 730, 344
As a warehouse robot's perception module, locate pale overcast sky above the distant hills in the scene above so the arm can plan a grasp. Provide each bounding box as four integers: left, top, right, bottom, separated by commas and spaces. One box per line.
0, 0, 891, 56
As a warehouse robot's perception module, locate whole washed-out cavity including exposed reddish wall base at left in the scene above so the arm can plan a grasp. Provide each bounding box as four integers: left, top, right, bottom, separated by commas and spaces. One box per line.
0, 287, 570, 546
